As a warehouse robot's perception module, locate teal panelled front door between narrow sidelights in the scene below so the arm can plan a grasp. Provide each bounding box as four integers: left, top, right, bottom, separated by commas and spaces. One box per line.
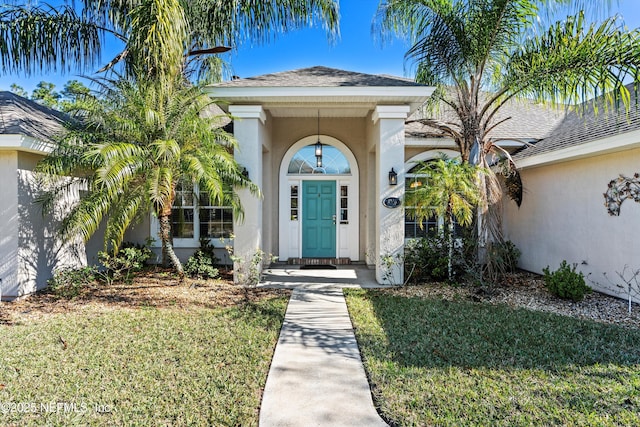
302, 181, 336, 258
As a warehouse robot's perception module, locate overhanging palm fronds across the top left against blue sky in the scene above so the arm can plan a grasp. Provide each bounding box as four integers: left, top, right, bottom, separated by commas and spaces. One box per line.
0, 0, 339, 80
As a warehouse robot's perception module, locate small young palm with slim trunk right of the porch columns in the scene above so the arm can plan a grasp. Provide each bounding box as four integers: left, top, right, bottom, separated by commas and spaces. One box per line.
405, 157, 483, 280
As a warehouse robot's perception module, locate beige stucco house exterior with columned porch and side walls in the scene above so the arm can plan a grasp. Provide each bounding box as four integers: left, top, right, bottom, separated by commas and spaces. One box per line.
5, 67, 640, 299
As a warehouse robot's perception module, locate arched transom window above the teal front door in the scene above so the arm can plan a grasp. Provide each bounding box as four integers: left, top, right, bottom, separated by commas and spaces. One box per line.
287, 144, 351, 175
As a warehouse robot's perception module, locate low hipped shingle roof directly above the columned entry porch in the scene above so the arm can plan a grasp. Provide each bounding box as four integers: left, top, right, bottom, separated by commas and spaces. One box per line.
215, 66, 424, 87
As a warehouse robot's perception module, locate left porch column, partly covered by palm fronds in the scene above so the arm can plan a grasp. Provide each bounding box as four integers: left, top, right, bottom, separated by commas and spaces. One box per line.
229, 105, 267, 282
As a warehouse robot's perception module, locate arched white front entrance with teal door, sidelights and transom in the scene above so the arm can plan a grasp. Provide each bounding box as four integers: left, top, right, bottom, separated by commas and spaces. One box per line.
275, 139, 363, 262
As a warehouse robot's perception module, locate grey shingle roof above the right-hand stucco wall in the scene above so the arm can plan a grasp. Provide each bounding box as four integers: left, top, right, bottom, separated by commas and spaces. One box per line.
513, 85, 640, 159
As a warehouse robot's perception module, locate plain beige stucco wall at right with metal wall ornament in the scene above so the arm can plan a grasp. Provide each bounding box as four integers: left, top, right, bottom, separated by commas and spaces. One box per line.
504, 149, 640, 295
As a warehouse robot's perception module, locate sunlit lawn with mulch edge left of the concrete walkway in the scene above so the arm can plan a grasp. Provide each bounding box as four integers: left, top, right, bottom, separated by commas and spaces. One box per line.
0, 276, 287, 426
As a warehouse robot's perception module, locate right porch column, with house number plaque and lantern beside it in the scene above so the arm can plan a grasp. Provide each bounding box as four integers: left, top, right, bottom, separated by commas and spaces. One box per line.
372, 105, 409, 285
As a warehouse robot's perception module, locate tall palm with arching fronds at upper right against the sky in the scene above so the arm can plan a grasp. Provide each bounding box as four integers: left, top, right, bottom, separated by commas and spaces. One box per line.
377, 0, 640, 241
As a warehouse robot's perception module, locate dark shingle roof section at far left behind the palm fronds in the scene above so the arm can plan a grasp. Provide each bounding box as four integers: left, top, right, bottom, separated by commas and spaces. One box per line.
0, 91, 68, 141
